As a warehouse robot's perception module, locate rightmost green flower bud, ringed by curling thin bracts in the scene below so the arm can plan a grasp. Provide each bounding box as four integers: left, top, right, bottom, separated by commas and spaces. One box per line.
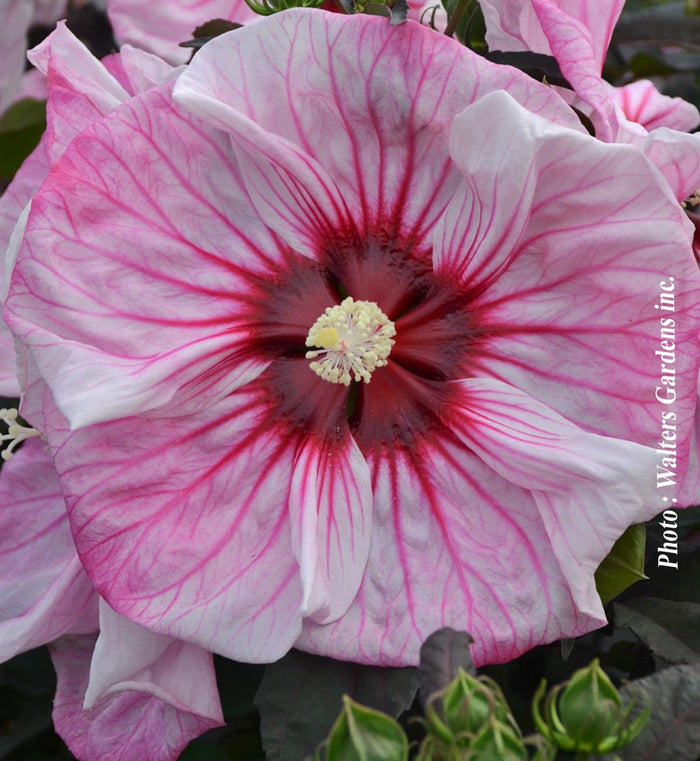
532, 658, 651, 753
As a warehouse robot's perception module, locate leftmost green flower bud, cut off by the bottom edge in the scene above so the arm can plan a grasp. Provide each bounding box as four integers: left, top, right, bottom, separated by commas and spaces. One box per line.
325, 695, 408, 761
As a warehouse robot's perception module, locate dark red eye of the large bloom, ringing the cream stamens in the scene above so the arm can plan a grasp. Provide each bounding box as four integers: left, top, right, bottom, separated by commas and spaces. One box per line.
252, 236, 477, 451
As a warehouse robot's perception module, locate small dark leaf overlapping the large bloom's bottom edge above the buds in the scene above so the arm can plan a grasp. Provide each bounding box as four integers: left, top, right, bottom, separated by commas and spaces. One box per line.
418, 627, 476, 705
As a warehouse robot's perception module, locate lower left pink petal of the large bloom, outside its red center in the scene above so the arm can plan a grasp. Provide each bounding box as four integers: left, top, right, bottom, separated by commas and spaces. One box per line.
44, 384, 302, 662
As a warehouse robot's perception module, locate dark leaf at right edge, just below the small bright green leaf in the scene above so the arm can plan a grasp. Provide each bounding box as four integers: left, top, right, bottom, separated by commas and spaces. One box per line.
613, 597, 700, 663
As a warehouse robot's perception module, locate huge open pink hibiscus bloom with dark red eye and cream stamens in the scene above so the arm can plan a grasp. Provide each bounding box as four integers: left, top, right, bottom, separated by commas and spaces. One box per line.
6, 11, 698, 664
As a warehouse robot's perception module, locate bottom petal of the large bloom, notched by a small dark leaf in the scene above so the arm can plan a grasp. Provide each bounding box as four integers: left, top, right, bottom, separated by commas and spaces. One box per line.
297, 380, 604, 666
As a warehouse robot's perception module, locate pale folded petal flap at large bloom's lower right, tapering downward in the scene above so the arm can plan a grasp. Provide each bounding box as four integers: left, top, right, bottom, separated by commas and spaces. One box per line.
454, 379, 659, 618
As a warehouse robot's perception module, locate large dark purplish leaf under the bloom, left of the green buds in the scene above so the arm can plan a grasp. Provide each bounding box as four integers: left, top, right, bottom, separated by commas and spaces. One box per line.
255, 650, 418, 761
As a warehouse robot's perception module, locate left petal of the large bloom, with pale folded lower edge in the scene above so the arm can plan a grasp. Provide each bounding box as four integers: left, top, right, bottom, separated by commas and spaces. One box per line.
6, 85, 286, 426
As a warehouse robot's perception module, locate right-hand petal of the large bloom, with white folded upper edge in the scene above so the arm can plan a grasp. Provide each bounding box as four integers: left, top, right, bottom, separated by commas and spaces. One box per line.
434, 93, 699, 458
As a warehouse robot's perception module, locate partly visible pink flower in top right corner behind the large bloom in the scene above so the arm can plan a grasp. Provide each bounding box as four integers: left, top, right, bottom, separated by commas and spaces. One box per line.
481, 0, 700, 201
